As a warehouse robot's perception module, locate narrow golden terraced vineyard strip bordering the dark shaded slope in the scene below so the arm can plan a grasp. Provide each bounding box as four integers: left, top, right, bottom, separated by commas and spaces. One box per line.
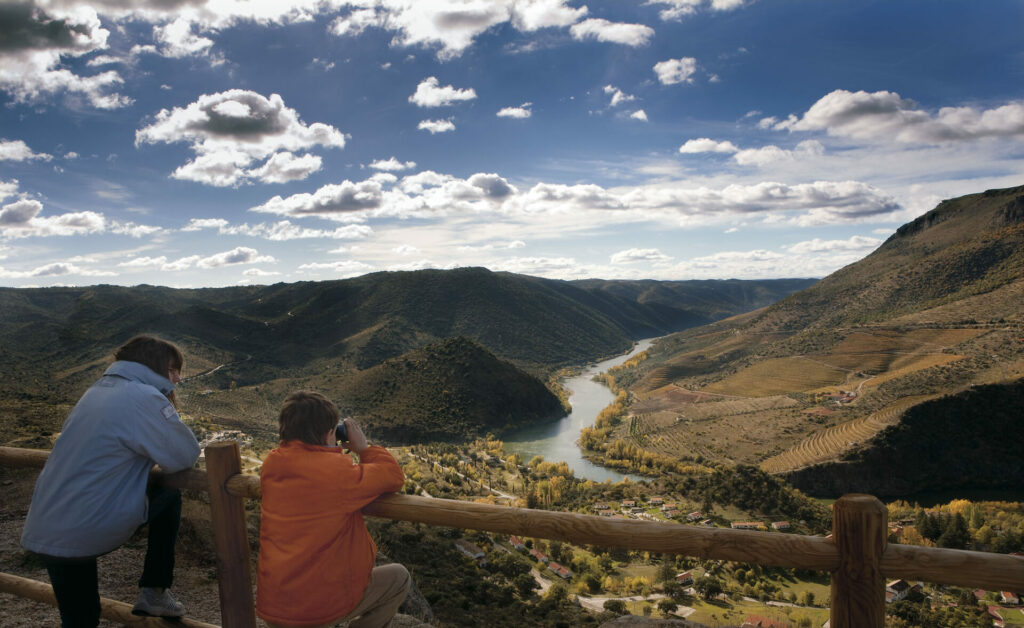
761, 394, 936, 473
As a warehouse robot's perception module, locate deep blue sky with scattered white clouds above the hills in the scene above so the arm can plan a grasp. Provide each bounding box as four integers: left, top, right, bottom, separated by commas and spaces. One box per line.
0, 0, 1024, 288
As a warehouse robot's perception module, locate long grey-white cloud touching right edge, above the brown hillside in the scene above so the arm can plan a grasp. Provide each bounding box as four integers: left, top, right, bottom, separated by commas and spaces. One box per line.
774, 89, 1024, 143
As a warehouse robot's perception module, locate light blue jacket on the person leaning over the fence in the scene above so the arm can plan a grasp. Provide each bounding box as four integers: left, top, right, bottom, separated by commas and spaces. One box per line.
22, 362, 200, 557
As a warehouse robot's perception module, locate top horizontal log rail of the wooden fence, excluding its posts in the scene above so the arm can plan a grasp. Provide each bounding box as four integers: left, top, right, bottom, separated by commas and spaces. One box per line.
0, 447, 1024, 591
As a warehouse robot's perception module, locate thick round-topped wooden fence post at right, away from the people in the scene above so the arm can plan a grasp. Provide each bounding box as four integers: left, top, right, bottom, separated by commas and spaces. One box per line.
831, 495, 889, 628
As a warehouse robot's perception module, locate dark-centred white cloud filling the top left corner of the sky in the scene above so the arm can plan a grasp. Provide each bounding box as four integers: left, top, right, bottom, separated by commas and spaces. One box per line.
0, 0, 132, 110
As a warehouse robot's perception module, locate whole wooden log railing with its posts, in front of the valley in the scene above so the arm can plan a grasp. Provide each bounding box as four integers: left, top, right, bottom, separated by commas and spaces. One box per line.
0, 443, 1024, 628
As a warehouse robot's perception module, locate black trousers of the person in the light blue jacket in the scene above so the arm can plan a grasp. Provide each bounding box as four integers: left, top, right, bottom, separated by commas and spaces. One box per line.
43, 487, 181, 628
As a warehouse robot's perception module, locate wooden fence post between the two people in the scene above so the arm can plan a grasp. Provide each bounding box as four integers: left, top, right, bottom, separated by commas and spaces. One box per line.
206, 441, 256, 628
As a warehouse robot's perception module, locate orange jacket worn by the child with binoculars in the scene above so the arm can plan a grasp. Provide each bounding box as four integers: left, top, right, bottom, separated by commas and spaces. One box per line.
256, 441, 404, 626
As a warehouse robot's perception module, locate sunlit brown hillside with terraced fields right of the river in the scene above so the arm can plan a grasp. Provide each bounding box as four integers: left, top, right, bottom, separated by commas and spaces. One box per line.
610, 183, 1024, 487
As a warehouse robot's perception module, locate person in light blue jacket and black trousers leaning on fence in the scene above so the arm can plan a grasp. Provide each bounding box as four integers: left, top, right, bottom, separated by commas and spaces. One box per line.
22, 336, 200, 628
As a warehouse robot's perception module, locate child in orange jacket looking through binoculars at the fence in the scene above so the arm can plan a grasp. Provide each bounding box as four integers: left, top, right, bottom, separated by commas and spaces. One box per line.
256, 391, 411, 628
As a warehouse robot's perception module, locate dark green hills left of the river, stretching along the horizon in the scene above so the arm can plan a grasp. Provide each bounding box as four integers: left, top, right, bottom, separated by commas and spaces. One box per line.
0, 268, 814, 437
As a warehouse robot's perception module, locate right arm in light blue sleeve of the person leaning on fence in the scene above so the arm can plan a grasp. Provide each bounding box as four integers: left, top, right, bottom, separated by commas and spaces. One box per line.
128, 389, 200, 473
